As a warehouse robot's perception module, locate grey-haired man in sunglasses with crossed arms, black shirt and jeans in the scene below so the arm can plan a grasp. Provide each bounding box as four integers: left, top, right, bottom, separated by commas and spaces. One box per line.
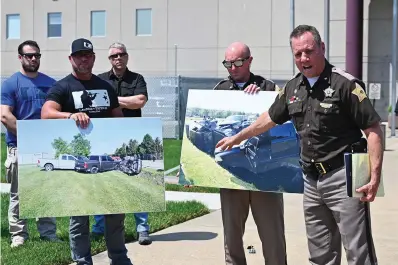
92, 42, 152, 245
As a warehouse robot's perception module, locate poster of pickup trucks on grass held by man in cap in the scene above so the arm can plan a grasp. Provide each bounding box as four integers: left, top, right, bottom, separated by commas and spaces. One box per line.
17, 118, 165, 218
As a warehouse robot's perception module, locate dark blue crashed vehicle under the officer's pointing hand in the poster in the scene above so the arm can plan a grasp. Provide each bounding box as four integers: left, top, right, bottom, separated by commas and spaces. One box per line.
214, 121, 304, 192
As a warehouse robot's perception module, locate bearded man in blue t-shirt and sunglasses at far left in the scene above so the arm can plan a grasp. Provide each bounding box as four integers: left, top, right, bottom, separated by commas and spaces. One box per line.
1, 40, 60, 247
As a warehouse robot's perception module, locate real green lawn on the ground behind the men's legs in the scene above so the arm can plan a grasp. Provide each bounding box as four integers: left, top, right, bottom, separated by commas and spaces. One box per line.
1, 194, 210, 265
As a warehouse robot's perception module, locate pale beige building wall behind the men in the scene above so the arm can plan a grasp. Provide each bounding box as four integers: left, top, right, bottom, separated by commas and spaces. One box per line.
1, 0, 392, 118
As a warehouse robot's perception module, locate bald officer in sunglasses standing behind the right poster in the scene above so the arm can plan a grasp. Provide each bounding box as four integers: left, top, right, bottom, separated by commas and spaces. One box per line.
214, 42, 287, 265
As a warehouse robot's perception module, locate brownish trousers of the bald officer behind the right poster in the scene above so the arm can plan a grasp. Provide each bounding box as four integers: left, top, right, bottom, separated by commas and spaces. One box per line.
220, 189, 287, 265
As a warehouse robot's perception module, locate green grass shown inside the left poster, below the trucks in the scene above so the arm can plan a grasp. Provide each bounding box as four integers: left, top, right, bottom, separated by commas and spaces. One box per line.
19, 165, 165, 218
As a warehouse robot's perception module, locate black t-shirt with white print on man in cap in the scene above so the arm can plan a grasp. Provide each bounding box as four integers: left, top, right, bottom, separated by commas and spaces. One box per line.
46, 74, 119, 118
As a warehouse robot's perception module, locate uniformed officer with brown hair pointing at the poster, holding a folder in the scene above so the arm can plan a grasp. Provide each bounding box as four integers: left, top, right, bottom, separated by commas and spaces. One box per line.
216, 25, 383, 265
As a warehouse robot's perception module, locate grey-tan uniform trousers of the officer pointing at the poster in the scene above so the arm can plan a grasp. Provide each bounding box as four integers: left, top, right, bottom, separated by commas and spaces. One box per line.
303, 167, 377, 265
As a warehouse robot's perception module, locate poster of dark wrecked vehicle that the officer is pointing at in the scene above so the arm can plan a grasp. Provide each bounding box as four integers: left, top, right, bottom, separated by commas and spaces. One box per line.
180, 90, 304, 193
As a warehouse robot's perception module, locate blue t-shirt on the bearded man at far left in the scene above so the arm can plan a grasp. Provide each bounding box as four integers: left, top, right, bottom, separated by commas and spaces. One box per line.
1, 72, 56, 145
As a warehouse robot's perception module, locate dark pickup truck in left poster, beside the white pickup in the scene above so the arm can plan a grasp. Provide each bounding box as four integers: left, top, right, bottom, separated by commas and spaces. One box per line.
74, 155, 120, 174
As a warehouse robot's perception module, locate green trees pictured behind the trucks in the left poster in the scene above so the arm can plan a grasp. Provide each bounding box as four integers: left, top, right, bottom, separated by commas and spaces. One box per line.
51, 133, 163, 159
